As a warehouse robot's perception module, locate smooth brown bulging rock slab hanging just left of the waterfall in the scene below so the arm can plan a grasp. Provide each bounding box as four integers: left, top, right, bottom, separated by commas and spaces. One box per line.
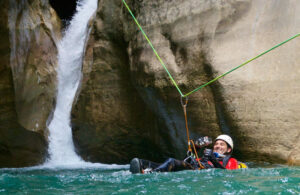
8, 0, 60, 133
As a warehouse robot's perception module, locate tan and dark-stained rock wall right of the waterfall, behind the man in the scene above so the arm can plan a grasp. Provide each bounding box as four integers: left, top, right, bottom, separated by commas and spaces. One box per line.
73, 0, 300, 163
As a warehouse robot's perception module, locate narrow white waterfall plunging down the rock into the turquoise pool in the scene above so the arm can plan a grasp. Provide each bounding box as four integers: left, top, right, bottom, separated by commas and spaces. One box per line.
46, 0, 97, 166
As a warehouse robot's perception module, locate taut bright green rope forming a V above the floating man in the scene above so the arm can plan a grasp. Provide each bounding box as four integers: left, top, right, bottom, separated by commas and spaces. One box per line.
122, 0, 300, 97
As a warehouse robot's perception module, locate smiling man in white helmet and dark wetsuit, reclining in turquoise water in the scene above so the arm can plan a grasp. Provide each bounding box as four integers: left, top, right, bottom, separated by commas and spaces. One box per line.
130, 135, 238, 173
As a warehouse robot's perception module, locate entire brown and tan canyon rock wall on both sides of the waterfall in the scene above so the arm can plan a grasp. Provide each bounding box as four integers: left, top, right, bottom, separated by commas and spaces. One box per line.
0, 0, 300, 167
